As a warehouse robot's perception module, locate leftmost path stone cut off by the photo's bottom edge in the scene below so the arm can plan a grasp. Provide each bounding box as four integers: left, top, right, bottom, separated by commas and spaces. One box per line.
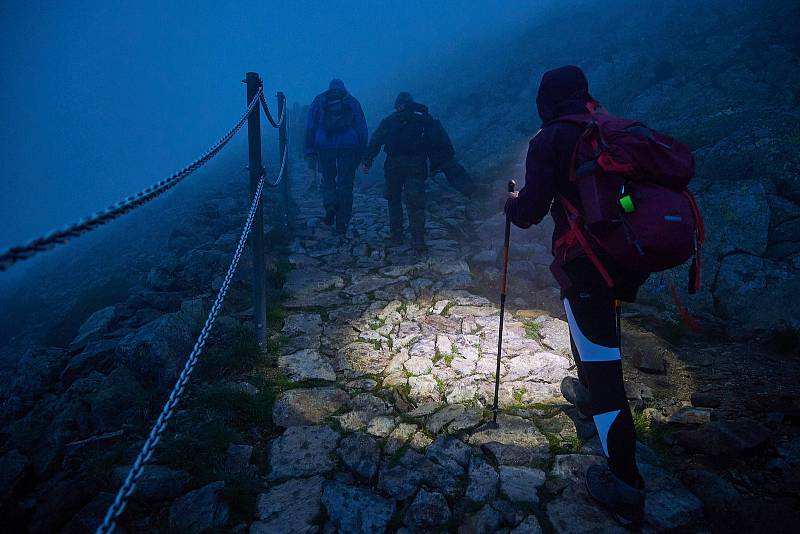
250, 476, 325, 534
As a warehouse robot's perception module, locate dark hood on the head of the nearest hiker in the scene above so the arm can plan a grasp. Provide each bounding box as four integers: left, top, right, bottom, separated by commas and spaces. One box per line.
536, 65, 594, 123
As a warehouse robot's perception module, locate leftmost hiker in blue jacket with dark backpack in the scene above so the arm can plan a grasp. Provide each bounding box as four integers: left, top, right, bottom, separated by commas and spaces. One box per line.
305, 78, 368, 235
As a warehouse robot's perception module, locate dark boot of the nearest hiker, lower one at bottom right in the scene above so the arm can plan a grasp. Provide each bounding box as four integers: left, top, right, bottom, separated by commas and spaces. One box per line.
586, 465, 645, 529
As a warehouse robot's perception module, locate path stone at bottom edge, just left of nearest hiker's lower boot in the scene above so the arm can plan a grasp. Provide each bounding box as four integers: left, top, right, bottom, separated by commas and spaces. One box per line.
547, 483, 628, 534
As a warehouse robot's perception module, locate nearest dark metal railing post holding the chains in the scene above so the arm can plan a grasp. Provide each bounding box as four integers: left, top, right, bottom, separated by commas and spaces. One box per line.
245, 72, 267, 347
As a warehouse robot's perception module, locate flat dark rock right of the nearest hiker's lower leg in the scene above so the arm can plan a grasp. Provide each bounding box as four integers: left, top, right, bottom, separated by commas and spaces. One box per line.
674, 419, 769, 456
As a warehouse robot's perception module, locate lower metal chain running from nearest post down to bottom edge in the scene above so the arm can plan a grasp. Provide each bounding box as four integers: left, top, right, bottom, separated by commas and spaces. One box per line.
96, 176, 264, 534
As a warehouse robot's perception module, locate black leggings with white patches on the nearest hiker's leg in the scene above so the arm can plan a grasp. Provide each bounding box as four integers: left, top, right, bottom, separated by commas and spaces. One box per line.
564, 288, 639, 485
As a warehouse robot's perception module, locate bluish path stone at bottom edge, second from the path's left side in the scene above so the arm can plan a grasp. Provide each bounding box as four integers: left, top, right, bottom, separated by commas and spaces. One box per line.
322, 482, 395, 534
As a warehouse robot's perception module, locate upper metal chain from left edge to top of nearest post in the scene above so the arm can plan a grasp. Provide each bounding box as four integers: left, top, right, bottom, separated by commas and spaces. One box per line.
0, 89, 262, 272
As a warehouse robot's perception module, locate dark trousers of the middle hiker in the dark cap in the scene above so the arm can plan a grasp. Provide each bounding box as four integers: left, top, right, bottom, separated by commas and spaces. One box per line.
384, 158, 428, 244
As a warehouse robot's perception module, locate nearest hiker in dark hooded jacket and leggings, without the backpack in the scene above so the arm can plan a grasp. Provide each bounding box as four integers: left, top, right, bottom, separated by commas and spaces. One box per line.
505, 66, 647, 524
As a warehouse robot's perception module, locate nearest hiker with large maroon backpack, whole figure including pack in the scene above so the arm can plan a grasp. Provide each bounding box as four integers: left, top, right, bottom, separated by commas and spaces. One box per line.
505, 66, 703, 526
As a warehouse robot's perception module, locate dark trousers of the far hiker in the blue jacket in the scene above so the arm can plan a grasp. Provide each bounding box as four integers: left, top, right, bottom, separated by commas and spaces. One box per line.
319, 147, 360, 229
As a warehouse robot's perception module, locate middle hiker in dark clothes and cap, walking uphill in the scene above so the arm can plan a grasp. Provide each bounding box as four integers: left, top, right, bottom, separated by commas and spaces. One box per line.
363, 91, 435, 254
